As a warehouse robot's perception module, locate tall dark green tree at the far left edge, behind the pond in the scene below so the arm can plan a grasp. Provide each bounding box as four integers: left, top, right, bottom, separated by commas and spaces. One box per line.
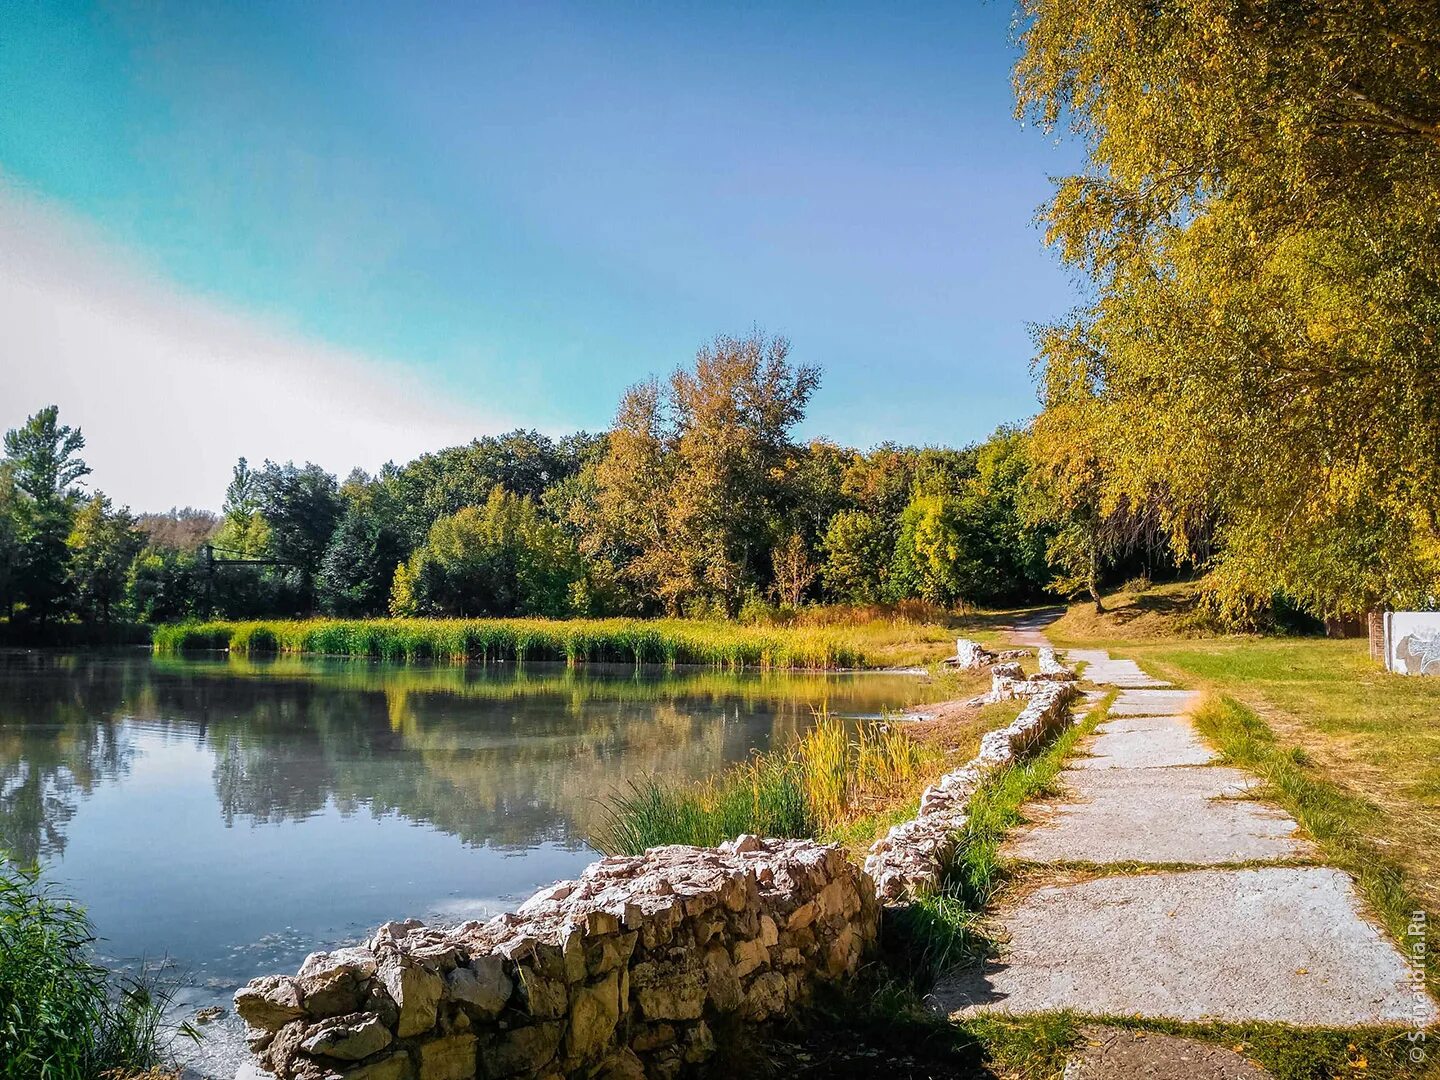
4, 405, 89, 622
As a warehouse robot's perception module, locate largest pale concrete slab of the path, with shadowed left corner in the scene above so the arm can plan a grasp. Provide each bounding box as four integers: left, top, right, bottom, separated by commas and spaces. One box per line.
930, 867, 1440, 1027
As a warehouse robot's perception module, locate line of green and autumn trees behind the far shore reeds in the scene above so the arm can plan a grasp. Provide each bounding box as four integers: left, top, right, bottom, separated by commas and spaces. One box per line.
0, 334, 1057, 622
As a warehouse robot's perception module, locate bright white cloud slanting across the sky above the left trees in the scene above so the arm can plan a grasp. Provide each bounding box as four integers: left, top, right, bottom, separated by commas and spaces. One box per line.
0, 180, 516, 510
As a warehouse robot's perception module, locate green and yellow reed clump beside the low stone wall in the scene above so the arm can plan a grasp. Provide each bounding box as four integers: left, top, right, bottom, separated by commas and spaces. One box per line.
592, 714, 929, 855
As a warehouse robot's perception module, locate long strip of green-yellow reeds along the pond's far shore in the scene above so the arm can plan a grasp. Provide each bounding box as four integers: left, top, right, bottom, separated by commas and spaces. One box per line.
153, 619, 886, 670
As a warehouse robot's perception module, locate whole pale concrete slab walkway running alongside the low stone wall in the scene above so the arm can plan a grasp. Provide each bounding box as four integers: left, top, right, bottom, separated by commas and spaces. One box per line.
932, 639, 1440, 1027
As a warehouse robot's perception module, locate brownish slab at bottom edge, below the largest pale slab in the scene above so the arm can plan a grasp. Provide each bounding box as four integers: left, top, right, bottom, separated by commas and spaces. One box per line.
1061, 1027, 1270, 1080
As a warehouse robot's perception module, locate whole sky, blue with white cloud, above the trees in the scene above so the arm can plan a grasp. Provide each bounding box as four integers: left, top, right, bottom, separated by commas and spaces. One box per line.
0, 0, 1079, 510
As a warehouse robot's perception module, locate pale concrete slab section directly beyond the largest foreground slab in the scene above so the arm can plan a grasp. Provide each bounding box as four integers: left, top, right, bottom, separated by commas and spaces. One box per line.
1002, 766, 1315, 865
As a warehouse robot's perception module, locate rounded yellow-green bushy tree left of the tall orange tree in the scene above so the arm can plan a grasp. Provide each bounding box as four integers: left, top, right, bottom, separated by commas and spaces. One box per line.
390, 487, 585, 616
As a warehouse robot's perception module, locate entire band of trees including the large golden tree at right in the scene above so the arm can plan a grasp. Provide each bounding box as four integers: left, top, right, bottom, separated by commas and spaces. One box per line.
8, 0, 1440, 629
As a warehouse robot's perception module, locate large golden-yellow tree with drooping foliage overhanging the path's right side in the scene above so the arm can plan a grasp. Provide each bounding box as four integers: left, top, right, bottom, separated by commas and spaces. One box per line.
1015, 0, 1440, 615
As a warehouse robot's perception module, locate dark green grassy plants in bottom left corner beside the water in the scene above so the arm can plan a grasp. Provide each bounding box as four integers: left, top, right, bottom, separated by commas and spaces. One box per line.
0, 855, 178, 1080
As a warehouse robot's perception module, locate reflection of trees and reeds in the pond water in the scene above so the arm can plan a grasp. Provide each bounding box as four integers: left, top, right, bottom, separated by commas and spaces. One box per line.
0, 654, 927, 858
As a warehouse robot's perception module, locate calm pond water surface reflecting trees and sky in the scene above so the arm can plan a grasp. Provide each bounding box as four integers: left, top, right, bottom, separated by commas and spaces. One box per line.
0, 652, 935, 1076
